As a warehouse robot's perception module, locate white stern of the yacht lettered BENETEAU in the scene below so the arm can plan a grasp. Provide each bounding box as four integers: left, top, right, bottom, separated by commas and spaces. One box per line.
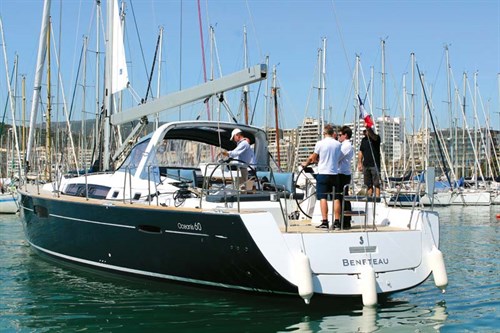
238, 208, 447, 302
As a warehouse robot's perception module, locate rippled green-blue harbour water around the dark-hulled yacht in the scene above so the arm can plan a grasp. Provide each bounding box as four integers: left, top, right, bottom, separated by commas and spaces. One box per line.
0, 206, 500, 332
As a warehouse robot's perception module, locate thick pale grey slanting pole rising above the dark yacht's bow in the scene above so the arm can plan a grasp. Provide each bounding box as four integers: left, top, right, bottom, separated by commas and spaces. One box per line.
25, 0, 50, 170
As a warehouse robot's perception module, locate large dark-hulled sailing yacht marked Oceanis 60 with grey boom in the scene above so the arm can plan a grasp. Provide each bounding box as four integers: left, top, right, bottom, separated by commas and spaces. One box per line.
19, 0, 448, 306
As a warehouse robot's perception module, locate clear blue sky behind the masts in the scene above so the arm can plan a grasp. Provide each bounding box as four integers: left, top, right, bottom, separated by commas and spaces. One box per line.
0, 0, 500, 128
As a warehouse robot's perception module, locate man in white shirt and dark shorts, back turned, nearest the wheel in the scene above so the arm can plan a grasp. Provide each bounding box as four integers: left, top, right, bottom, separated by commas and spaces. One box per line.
302, 125, 341, 229
